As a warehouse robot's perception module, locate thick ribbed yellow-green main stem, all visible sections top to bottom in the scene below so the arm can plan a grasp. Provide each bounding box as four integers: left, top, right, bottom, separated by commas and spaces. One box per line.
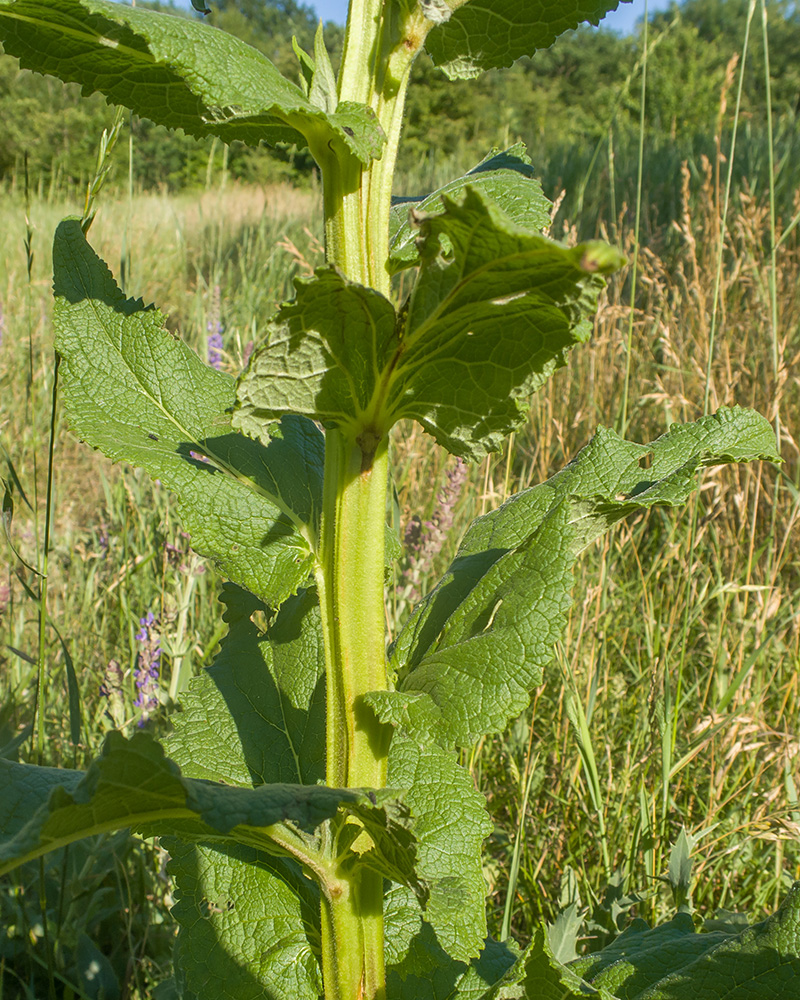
315, 0, 430, 1000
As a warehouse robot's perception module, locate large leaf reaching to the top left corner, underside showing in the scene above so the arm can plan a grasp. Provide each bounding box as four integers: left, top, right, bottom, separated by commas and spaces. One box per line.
0, 0, 384, 163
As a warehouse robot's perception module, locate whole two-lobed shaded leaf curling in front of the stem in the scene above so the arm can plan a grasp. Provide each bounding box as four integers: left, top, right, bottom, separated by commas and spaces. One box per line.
234, 188, 621, 459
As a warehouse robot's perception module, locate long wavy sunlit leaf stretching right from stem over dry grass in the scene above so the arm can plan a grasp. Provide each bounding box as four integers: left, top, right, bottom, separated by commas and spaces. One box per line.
391, 408, 778, 746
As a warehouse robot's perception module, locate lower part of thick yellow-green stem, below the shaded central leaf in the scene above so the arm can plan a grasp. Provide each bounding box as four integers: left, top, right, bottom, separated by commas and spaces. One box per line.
317, 430, 388, 1000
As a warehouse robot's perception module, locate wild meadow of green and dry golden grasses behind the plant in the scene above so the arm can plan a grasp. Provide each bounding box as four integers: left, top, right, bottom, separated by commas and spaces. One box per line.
0, 0, 800, 997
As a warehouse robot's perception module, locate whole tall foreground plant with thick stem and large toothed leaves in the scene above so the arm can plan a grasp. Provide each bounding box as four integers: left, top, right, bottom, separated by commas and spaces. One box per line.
0, 0, 800, 1000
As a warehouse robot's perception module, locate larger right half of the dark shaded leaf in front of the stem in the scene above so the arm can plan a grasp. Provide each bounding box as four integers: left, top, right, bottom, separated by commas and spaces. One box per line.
394, 188, 623, 460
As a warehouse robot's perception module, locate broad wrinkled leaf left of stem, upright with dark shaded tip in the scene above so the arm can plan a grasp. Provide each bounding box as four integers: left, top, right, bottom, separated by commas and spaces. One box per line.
53, 220, 324, 605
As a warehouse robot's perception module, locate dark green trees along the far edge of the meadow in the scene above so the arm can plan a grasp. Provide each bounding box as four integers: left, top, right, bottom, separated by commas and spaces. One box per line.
0, 0, 800, 190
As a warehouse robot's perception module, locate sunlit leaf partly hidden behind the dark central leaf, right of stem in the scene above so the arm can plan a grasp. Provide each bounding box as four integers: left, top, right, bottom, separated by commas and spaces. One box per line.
389, 142, 552, 273
